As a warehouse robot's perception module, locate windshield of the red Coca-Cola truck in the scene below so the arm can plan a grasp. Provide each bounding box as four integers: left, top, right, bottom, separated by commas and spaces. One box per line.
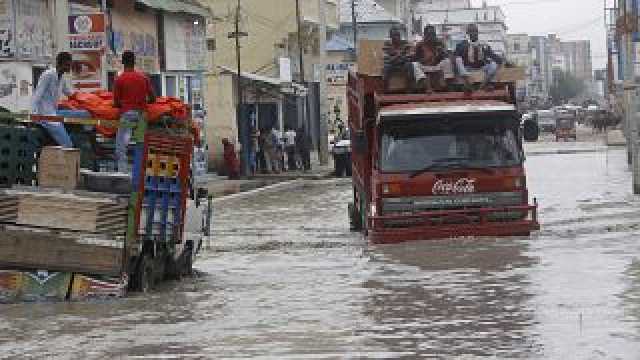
380, 118, 522, 172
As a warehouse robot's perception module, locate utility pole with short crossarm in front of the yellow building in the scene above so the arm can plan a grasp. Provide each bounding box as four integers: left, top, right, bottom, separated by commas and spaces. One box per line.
228, 0, 251, 177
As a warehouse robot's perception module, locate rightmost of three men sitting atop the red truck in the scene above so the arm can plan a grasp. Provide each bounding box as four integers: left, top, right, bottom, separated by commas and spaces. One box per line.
455, 24, 503, 88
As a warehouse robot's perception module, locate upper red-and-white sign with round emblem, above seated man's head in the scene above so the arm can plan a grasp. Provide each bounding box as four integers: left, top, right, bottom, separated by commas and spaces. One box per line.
69, 14, 106, 51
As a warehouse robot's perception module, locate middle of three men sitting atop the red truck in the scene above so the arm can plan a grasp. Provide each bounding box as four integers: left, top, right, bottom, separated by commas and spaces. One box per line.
413, 25, 452, 93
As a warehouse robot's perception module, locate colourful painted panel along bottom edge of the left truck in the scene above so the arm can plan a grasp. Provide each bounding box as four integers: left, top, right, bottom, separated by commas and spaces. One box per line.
0, 270, 129, 304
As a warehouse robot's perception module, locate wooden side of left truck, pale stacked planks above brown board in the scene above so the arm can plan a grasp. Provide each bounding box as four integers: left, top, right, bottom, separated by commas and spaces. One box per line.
0, 188, 128, 275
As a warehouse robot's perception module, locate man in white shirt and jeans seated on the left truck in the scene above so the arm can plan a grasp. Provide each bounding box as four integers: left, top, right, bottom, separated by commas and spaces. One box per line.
32, 52, 73, 148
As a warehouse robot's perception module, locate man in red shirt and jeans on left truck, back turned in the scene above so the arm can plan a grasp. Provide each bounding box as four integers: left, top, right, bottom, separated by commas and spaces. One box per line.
113, 50, 156, 173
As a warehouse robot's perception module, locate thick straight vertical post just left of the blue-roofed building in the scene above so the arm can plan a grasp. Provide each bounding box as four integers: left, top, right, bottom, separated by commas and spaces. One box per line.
318, 0, 329, 165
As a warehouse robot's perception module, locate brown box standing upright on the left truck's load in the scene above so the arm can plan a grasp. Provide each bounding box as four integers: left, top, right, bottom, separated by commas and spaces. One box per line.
38, 146, 80, 190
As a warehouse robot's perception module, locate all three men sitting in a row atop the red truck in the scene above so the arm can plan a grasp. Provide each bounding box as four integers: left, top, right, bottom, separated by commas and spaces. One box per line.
383, 24, 510, 93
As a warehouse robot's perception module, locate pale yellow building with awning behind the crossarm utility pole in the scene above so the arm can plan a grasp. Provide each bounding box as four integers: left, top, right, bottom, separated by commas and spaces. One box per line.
200, 0, 339, 170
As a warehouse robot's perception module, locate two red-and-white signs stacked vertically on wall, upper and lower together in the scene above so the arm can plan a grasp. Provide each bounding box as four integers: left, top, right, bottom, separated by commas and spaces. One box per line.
69, 14, 106, 91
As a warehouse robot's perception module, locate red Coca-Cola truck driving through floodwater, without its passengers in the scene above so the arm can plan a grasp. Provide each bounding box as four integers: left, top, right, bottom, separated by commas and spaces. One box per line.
347, 73, 539, 243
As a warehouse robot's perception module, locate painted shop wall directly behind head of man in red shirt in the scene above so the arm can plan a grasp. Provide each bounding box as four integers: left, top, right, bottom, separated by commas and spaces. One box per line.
107, 1, 160, 73
